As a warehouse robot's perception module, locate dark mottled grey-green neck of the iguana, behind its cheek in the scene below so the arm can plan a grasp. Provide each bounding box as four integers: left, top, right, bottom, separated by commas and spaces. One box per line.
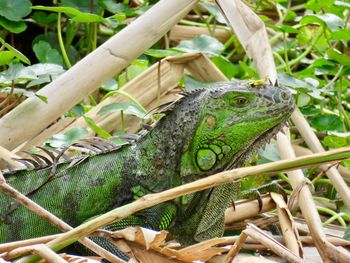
124, 91, 203, 192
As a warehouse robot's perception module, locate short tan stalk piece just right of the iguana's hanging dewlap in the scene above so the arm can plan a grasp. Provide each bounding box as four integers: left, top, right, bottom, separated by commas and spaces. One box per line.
225, 195, 276, 224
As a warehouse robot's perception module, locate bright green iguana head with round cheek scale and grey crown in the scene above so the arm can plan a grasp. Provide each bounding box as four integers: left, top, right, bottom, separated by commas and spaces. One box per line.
181, 82, 294, 177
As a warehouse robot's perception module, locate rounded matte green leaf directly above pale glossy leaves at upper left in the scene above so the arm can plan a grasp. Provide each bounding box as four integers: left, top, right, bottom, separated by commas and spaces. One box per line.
33, 40, 63, 65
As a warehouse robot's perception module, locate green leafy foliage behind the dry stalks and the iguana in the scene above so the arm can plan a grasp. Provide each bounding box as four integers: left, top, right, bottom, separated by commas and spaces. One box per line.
0, 0, 350, 227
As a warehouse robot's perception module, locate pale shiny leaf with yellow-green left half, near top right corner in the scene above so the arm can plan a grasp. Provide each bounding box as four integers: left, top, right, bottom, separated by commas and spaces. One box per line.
300, 14, 344, 32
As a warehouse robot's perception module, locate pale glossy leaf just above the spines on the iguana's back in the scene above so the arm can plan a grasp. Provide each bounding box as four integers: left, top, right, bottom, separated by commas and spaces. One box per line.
46, 128, 88, 148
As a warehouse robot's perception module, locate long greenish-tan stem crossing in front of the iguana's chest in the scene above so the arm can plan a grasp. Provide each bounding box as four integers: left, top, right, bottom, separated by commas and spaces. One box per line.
18, 147, 350, 262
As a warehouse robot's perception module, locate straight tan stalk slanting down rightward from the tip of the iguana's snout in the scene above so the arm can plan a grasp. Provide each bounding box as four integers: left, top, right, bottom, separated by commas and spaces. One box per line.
292, 109, 350, 209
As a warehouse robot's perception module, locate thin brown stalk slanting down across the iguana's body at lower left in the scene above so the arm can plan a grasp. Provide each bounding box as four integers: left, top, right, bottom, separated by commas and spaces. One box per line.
0, 184, 124, 262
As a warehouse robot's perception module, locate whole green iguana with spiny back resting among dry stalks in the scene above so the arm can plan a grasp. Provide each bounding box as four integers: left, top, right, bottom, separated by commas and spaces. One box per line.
0, 81, 294, 260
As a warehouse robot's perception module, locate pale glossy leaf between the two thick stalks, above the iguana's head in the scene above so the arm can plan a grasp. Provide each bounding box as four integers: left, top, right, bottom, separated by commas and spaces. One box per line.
175, 35, 224, 55
